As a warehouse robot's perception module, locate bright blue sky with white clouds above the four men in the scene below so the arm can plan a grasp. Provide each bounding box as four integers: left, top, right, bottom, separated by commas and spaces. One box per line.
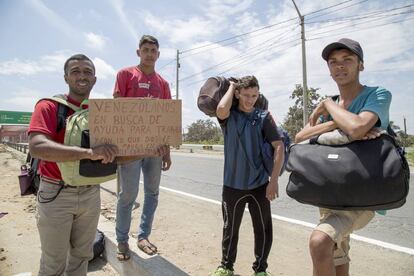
0, 0, 414, 134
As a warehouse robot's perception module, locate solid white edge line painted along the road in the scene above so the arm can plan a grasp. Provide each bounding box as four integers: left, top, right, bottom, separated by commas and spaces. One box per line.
160, 186, 414, 255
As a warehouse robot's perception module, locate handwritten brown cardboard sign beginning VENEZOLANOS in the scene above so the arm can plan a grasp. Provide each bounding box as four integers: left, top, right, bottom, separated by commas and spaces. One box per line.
89, 98, 182, 156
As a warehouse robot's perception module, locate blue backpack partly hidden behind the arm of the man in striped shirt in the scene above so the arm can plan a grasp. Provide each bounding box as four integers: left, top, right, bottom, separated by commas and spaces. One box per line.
261, 127, 290, 176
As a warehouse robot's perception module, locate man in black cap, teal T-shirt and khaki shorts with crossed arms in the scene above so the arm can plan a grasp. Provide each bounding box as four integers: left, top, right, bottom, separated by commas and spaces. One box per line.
295, 38, 391, 276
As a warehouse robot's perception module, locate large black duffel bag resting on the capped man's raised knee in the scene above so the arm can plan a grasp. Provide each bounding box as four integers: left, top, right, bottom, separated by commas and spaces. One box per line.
286, 134, 410, 210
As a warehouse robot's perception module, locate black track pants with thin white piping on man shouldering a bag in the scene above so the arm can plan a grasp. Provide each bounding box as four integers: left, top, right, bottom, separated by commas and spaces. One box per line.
221, 184, 273, 272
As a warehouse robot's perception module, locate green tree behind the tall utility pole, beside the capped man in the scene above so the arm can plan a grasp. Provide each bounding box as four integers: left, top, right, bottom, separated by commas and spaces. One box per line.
282, 84, 325, 139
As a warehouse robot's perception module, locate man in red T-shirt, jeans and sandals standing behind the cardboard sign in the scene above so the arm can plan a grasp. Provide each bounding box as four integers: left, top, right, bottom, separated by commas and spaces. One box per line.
114, 35, 171, 261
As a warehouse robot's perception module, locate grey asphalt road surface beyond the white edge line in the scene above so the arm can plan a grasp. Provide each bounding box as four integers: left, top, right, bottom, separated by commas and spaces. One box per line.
161, 152, 414, 249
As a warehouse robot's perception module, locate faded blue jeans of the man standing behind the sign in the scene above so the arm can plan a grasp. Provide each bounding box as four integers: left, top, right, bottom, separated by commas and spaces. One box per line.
115, 157, 162, 243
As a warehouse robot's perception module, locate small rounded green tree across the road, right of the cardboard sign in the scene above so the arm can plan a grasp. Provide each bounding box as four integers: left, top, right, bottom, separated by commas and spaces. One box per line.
185, 119, 222, 144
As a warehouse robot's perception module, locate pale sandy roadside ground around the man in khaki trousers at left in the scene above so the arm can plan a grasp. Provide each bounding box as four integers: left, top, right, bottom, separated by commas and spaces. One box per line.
0, 144, 118, 276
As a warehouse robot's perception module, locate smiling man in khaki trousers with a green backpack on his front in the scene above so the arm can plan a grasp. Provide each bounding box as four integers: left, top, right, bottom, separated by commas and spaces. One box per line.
29, 54, 118, 276
